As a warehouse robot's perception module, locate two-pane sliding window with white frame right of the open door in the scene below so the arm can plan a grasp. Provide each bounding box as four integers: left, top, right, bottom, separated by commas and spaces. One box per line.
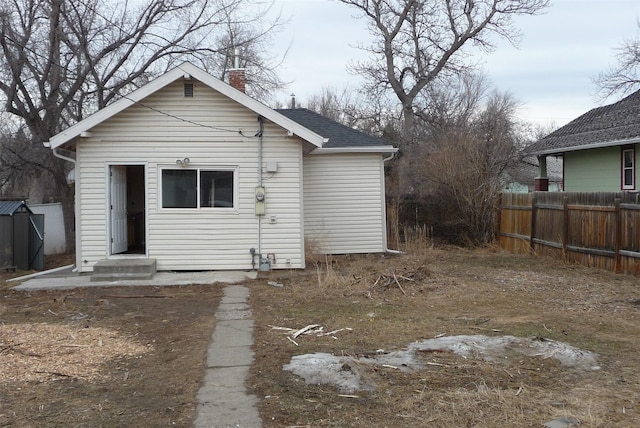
162, 168, 236, 208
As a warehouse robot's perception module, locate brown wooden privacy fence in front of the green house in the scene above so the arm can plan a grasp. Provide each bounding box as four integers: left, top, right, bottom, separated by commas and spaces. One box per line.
496, 192, 640, 275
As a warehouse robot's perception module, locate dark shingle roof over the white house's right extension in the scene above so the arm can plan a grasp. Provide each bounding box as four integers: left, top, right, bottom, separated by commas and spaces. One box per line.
276, 108, 391, 148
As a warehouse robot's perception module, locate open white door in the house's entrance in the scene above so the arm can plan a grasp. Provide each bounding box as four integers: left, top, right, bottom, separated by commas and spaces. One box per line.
109, 165, 128, 254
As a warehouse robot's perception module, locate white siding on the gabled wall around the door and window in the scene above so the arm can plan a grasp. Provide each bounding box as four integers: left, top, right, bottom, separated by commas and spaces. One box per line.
77, 81, 304, 271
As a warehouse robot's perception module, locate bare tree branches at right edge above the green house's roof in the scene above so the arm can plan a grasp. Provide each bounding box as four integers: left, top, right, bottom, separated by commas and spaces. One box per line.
594, 21, 640, 99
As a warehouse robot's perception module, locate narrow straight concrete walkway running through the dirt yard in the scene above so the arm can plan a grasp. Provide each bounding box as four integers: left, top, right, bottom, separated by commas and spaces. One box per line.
194, 285, 262, 428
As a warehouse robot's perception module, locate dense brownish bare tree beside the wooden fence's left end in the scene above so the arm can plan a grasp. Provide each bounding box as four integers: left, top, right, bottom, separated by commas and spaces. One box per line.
422, 88, 523, 243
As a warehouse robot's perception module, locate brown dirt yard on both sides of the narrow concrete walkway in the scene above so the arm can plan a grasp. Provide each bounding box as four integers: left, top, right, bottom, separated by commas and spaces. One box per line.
0, 248, 640, 427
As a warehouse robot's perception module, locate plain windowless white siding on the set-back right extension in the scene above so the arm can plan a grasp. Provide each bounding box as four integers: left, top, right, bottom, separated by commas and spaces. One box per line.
304, 154, 386, 254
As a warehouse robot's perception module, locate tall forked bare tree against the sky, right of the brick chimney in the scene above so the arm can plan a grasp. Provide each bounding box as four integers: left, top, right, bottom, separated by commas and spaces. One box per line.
340, 0, 549, 139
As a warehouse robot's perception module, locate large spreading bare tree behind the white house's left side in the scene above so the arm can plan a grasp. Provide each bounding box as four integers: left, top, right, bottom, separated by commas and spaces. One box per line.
0, 0, 284, 248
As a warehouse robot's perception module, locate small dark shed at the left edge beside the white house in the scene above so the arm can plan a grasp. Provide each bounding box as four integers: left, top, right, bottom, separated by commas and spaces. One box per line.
0, 200, 44, 270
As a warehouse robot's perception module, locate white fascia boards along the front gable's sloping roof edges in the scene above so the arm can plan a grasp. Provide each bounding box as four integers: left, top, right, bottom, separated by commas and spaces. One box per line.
45, 62, 327, 149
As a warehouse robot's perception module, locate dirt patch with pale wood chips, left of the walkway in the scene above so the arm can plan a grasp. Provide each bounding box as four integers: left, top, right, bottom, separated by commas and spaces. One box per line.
0, 272, 223, 427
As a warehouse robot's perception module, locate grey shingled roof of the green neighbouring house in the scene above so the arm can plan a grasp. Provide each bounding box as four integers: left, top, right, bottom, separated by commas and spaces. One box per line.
528, 91, 640, 154
